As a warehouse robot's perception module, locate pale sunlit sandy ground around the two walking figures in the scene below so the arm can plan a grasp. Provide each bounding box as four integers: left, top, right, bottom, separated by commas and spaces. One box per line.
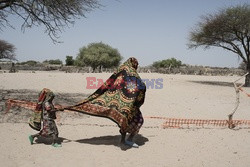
0, 72, 250, 167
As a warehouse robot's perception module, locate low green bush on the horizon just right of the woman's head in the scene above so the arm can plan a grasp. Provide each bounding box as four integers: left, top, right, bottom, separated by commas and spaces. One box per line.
152, 58, 182, 68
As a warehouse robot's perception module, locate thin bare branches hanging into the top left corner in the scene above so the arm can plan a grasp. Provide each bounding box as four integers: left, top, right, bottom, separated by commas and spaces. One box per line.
0, 0, 100, 42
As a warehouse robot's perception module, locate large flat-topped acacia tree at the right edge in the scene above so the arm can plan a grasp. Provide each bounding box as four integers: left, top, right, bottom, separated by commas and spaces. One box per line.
188, 4, 250, 87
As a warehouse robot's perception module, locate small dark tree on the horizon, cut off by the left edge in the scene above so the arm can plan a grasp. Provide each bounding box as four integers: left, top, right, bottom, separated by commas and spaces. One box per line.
0, 40, 16, 60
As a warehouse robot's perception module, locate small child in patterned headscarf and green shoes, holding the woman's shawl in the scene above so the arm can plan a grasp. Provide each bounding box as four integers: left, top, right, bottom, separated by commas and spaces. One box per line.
29, 88, 61, 147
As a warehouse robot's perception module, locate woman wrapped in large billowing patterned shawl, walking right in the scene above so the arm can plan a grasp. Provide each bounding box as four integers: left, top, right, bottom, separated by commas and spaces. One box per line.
66, 57, 146, 147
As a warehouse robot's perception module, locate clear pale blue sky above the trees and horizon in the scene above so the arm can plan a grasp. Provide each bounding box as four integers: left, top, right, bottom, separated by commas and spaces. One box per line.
0, 0, 250, 67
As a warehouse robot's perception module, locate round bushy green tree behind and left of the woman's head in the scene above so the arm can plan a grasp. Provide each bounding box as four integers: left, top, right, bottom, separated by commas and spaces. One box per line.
76, 42, 122, 71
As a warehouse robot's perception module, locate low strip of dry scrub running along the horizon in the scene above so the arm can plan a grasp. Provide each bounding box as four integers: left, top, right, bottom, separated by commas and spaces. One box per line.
0, 62, 245, 75
